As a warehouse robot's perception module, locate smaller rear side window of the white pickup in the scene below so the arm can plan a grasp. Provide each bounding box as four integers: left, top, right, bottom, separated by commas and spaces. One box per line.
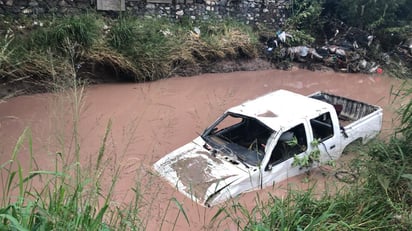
310, 112, 333, 141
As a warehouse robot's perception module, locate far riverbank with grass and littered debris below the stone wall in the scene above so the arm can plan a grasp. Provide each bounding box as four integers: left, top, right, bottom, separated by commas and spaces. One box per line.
0, 9, 412, 99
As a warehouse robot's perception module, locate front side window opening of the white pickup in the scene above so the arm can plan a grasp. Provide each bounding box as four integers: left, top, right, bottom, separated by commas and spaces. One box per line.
268, 124, 308, 169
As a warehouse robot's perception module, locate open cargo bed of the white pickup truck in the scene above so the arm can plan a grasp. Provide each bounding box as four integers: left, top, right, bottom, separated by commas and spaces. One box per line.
309, 92, 380, 127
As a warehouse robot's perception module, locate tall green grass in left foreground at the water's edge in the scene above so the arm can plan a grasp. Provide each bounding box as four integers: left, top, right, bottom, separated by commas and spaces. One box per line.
0, 46, 189, 230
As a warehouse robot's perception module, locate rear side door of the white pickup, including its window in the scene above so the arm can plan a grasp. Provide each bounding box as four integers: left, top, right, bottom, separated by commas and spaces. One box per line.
310, 112, 340, 162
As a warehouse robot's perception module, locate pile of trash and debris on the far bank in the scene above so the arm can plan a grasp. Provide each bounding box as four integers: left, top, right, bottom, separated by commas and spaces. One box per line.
265, 27, 412, 74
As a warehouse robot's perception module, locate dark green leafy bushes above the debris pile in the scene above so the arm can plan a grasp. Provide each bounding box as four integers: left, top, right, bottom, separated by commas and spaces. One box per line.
286, 0, 412, 45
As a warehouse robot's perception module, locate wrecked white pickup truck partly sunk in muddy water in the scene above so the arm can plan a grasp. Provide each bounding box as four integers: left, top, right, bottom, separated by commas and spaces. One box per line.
154, 90, 382, 207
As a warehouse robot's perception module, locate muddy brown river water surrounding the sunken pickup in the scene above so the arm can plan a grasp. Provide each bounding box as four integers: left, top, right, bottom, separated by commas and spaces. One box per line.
0, 70, 401, 230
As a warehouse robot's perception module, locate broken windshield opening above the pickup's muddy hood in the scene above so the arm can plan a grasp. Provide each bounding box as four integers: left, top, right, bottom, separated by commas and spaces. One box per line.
202, 113, 274, 166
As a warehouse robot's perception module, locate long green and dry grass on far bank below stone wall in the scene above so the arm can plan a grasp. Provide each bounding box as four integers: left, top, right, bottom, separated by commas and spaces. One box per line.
0, 12, 258, 86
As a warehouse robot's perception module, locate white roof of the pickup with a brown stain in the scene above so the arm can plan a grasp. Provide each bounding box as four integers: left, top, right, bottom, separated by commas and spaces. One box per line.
228, 90, 334, 131
